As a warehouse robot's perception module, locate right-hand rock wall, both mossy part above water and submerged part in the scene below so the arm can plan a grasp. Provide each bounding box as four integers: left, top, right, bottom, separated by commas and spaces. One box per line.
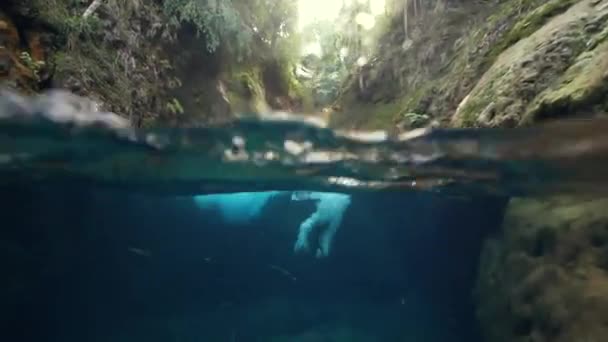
332, 0, 608, 342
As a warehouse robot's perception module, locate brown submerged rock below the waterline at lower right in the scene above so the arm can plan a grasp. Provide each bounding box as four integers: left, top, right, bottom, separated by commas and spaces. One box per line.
477, 198, 608, 342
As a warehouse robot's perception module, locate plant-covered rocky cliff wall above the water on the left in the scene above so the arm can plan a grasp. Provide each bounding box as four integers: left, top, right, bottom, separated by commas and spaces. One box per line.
0, 0, 302, 127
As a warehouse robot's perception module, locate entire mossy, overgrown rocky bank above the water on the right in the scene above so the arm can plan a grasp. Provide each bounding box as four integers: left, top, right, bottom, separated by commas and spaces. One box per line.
333, 0, 608, 129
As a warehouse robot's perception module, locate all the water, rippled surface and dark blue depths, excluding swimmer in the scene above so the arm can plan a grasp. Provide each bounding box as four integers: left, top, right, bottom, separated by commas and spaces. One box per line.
0, 89, 608, 342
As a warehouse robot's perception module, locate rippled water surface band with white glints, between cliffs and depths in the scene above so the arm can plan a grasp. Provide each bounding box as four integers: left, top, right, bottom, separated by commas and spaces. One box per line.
0, 92, 608, 195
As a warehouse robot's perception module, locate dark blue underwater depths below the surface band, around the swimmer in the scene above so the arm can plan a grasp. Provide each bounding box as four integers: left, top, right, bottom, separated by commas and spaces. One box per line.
0, 186, 504, 342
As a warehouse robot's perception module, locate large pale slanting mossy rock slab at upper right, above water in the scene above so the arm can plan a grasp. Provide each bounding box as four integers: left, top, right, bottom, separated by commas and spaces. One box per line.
452, 0, 608, 127
